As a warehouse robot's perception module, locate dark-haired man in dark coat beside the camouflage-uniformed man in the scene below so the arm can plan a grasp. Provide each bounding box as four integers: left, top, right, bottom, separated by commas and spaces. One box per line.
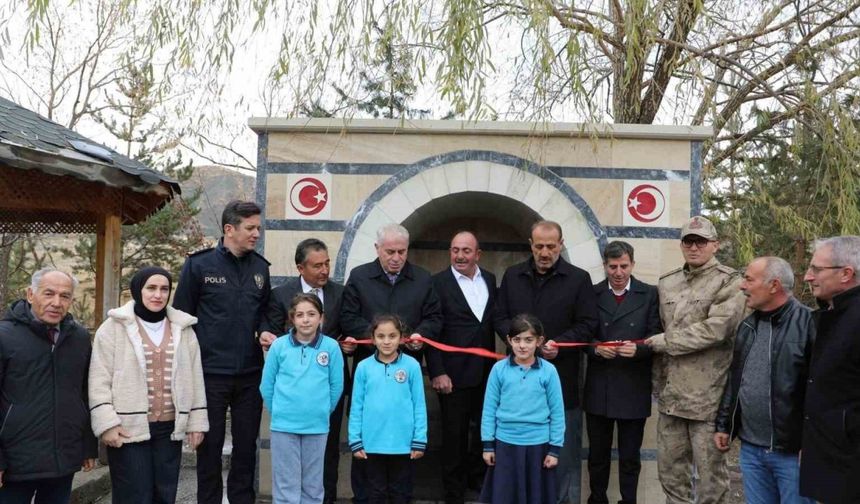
583, 241, 663, 504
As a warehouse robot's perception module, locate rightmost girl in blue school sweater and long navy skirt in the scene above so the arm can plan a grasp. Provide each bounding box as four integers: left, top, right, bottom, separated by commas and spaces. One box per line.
479, 314, 564, 504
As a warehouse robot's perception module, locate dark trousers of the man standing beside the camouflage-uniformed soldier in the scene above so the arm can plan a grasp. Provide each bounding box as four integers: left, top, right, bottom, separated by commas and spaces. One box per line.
586, 413, 645, 504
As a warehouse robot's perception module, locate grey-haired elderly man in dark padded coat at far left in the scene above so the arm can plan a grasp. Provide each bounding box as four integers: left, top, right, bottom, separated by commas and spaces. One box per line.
0, 268, 98, 504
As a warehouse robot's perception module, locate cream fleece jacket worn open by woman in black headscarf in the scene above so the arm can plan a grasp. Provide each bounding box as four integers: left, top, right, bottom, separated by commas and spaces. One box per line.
89, 301, 209, 443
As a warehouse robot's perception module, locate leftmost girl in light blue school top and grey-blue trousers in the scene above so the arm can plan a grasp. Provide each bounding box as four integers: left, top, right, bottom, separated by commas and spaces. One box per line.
260, 293, 343, 504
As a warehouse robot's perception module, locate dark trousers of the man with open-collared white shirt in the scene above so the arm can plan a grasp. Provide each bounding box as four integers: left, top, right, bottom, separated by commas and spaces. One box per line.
439, 387, 486, 504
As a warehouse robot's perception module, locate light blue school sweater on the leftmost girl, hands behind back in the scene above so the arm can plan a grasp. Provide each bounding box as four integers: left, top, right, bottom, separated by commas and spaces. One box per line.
260, 330, 343, 434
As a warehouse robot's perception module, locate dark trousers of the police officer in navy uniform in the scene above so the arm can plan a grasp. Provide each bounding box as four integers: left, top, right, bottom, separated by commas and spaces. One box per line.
197, 372, 263, 504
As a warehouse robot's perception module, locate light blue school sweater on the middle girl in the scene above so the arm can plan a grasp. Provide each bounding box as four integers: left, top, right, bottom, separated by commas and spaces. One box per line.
349, 353, 427, 455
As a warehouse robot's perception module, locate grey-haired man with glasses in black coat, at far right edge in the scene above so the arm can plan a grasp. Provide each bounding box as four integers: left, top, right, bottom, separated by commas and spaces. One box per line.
800, 236, 860, 504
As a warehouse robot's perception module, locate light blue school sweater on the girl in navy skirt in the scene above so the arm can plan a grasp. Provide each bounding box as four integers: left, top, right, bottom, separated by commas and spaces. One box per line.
481, 355, 564, 457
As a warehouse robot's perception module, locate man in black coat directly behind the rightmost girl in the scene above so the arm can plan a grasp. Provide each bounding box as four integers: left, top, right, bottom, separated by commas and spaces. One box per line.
495, 221, 598, 502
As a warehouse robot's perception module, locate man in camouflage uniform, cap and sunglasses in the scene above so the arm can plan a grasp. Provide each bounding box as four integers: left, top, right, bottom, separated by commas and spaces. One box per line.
646, 216, 745, 504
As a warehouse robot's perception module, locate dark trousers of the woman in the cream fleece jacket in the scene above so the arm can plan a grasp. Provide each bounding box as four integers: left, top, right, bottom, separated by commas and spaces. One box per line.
107, 422, 182, 504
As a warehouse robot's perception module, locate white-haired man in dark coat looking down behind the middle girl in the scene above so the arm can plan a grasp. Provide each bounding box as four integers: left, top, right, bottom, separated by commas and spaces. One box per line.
340, 224, 442, 503
